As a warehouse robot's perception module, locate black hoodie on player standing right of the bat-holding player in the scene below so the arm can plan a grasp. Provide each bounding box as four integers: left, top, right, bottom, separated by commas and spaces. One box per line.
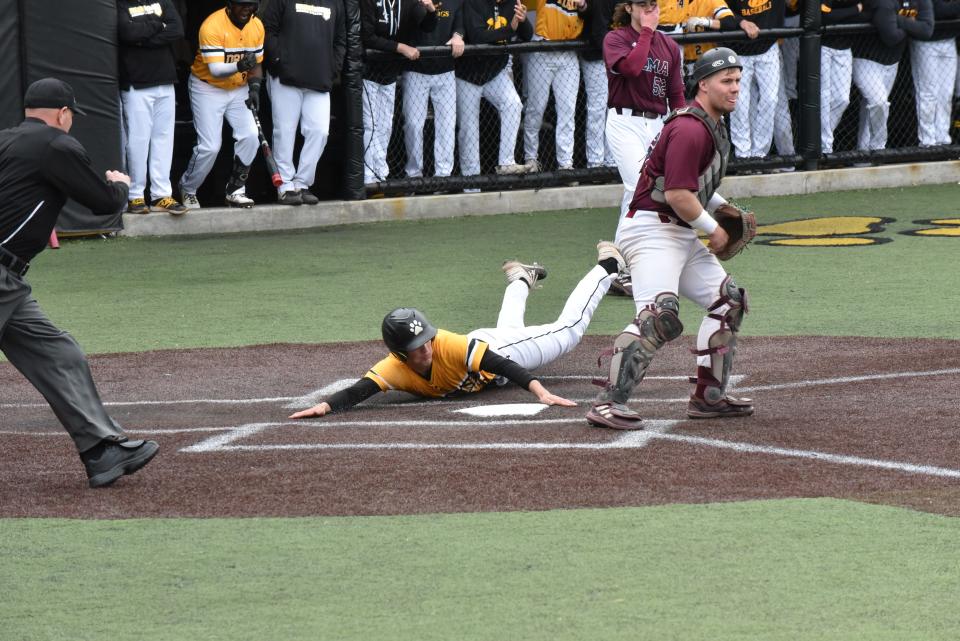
260, 0, 347, 91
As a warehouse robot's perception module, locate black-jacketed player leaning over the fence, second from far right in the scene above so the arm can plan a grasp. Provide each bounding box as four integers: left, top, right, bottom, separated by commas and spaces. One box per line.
853, 0, 933, 151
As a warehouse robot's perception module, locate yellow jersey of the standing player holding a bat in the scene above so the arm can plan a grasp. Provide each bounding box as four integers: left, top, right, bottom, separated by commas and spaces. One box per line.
190, 9, 264, 89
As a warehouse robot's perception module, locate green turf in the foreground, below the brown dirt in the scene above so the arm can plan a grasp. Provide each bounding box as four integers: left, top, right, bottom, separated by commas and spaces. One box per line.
0, 499, 960, 641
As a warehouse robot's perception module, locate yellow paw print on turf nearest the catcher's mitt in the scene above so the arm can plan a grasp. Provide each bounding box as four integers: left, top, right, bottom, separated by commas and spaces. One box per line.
757, 216, 895, 247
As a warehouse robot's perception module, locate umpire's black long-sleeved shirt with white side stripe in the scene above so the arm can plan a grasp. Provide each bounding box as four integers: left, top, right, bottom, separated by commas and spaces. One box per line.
0, 118, 129, 262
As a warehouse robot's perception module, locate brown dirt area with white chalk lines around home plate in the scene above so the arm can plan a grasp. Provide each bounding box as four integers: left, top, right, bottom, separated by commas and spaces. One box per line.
0, 337, 960, 518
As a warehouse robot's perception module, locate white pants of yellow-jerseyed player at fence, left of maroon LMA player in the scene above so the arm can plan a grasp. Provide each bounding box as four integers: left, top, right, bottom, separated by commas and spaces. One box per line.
523, 51, 580, 167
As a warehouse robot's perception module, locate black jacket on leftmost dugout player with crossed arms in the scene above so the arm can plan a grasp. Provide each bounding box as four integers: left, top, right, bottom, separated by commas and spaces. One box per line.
117, 0, 183, 90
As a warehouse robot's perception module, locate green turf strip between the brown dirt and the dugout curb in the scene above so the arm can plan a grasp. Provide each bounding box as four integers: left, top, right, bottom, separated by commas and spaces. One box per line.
22, 185, 960, 353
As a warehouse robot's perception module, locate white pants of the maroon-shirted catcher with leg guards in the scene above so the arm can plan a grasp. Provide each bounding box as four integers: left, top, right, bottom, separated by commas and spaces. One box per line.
615, 210, 730, 367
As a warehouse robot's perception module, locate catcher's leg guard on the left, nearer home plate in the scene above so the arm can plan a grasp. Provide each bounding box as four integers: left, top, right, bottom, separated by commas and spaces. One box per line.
600, 293, 683, 403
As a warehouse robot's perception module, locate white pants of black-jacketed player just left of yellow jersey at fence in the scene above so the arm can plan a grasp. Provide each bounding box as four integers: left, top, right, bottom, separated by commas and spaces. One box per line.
457, 65, 523, 176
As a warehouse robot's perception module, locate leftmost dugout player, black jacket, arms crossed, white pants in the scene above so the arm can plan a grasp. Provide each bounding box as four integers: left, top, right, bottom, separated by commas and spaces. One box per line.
117, 0, 187, 216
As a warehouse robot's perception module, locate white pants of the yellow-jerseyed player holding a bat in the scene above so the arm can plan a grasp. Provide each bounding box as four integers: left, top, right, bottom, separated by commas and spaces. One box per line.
180, 74, 260, 194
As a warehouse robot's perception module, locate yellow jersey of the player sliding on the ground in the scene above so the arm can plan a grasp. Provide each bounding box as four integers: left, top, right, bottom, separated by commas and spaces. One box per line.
364, 329, 495, 398
